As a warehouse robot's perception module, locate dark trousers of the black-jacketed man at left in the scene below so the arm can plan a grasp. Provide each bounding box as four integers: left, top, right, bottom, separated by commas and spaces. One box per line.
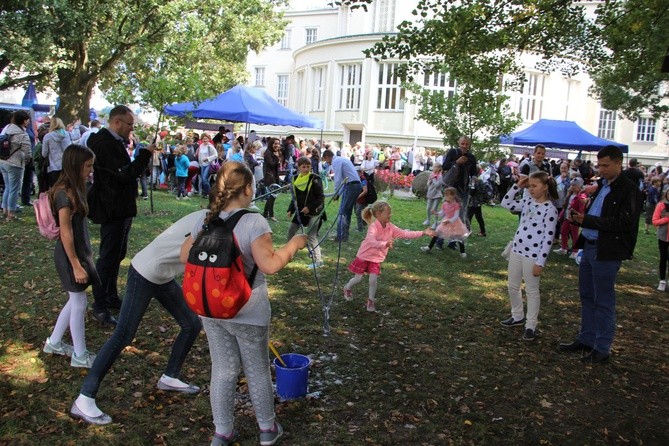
93, 217, 132, 313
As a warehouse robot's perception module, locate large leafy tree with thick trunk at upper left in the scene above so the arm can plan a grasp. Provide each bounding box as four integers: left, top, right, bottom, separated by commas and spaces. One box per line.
0, 0, 285, 121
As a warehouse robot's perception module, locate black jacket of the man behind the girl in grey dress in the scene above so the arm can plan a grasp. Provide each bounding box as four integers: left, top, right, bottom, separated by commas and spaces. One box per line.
88, 129, 151, 224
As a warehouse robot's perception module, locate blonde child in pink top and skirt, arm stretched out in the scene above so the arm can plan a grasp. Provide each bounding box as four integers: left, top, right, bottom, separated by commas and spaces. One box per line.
344, 201, 434, 312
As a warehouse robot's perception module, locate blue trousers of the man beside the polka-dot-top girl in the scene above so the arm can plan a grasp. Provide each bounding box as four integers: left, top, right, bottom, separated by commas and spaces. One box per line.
578, 243, 622, 354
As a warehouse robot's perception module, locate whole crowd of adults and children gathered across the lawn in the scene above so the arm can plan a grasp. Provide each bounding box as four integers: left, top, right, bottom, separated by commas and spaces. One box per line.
0, 106, 656, 445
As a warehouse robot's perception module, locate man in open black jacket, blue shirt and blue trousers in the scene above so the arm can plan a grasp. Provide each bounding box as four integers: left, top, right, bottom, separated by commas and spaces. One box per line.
560, 146, 641, 363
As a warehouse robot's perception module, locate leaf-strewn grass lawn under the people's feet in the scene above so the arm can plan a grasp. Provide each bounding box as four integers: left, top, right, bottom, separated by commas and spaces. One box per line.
0, 191, 669, 446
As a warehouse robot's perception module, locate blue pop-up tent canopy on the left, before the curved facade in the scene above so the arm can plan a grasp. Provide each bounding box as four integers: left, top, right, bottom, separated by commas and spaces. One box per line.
163, 85, 323, 129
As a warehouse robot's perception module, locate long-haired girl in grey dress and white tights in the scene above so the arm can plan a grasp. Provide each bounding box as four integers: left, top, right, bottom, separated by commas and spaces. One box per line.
43, 144, 100, 368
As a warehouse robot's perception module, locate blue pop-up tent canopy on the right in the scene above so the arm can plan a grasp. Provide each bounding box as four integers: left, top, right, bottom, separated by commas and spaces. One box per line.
500, 119, 629, 153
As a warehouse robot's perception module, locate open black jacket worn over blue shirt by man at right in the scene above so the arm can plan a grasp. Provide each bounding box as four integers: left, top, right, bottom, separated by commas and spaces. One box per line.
576, 174, 641, 260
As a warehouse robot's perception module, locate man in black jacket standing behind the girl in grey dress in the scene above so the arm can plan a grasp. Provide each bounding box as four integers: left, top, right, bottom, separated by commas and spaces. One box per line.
88, 105, 155, 325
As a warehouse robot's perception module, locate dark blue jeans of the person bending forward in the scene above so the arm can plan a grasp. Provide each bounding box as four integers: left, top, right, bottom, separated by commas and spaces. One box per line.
81, 265, 202, 398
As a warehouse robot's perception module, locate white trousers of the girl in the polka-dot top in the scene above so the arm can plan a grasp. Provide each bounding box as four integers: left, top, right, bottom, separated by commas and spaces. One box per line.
508, 252, 541, 330
